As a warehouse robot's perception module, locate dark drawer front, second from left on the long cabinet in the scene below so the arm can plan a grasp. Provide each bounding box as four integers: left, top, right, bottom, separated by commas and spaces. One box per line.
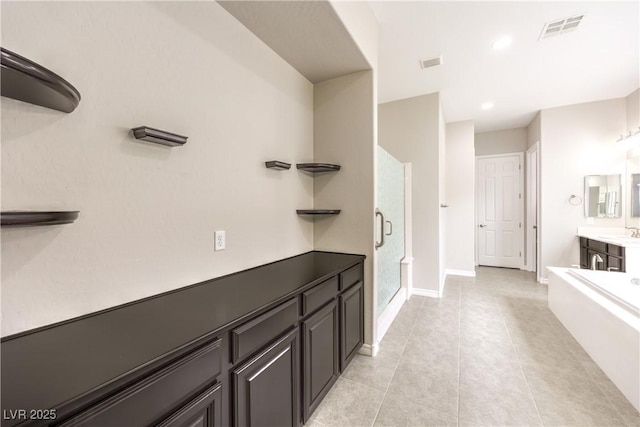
231, 298, 298, 363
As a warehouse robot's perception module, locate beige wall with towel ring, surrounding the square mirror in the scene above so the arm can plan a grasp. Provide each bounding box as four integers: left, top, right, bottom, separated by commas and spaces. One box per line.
539, 98, 626, 277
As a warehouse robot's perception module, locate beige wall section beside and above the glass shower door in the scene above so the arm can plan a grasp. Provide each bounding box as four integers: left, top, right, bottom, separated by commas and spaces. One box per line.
378, 93, 444, 296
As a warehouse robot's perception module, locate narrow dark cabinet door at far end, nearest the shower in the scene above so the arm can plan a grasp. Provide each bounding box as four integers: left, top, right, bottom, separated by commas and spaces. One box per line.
340, 282, 364, 372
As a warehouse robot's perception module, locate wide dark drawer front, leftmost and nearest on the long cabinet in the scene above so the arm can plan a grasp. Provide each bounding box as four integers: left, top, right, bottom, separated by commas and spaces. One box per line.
62, 339, 222, 426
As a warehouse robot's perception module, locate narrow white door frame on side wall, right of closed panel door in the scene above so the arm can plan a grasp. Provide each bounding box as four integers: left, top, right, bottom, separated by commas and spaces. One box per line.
525, 141, 540, 279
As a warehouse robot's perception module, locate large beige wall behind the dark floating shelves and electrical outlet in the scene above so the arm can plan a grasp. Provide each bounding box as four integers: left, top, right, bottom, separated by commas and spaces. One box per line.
1, 2, 316, 335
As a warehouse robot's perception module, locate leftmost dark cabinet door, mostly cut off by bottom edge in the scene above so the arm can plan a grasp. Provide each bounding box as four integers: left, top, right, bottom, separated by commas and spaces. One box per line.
158, 384, 222, 427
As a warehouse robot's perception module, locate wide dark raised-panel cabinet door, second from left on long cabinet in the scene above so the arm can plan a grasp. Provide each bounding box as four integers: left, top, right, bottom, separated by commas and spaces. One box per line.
232, 328, 300, 427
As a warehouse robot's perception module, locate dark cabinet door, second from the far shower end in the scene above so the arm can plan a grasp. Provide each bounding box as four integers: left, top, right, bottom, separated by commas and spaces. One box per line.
302, 299, 340, 422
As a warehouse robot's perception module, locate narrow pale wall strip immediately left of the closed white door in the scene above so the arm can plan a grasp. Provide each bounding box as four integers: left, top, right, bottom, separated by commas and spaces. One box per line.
444, 120, 475, 275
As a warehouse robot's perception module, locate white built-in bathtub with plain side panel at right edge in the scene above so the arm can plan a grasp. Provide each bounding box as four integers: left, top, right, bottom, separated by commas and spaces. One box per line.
549, 267, 640, 411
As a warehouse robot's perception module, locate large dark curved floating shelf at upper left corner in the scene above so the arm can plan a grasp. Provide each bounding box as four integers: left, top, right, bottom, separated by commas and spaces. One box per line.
0, 47, 80, 113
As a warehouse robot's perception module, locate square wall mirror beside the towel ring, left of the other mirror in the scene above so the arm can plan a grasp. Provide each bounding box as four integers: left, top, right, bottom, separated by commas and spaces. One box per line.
584, 174, 622, 218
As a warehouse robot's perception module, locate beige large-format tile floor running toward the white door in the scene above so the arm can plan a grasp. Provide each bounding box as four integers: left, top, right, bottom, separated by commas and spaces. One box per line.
305, 267, 640, 427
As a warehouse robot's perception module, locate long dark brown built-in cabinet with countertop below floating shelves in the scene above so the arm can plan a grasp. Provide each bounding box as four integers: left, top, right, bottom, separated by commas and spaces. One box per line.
0, 251, 364, 427
